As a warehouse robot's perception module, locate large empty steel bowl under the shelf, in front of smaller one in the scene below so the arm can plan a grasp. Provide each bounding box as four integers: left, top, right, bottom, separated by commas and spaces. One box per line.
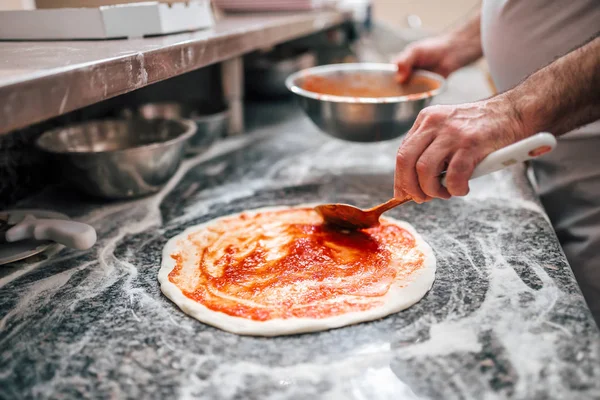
36, 119, 196, 199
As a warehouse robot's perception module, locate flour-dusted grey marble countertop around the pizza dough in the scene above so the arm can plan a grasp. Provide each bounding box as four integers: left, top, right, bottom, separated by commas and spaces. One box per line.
0, 67, 600, 400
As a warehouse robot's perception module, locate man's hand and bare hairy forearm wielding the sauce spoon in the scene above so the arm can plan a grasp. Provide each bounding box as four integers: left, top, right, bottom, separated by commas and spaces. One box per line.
394, 33, 600, 203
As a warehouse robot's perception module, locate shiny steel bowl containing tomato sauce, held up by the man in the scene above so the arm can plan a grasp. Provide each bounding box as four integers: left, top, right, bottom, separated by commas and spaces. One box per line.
286, 63, 445, 142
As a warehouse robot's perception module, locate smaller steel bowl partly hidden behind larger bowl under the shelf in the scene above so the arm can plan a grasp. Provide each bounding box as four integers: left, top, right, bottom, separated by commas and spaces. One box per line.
124, 102, 229, 153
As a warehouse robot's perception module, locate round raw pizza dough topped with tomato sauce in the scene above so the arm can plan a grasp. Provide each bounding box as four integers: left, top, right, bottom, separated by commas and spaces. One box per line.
158, 205, 436, 336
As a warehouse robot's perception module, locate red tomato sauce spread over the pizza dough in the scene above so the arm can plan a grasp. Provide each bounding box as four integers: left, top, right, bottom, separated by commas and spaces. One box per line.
169, 208, 423, 321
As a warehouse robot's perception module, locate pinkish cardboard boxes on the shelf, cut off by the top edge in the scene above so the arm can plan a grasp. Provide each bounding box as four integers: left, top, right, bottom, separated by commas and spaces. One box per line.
214, 0, 337, 12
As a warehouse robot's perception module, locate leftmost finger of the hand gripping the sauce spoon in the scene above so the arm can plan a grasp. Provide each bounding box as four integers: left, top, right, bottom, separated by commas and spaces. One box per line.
394, 131, 433, 203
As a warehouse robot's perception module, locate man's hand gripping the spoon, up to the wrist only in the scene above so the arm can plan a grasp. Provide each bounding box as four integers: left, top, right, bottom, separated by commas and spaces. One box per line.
394, 96, 535, 203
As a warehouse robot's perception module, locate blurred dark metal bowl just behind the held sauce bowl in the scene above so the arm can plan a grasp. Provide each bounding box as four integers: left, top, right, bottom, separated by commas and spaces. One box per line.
244, 50, 317, 99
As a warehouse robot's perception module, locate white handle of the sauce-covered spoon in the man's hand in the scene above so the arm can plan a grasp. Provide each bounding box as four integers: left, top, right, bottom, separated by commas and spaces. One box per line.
441, 132, 556, 186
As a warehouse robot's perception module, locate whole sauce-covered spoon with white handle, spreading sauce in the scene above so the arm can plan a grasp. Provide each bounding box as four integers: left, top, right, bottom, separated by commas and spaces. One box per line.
315, 132, 556, 229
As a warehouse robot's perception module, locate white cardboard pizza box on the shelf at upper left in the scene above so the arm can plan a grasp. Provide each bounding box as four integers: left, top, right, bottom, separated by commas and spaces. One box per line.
0, 0, 214, 40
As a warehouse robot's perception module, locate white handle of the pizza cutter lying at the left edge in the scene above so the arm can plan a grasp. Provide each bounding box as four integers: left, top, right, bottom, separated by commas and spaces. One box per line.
0, 213, 96, 250
